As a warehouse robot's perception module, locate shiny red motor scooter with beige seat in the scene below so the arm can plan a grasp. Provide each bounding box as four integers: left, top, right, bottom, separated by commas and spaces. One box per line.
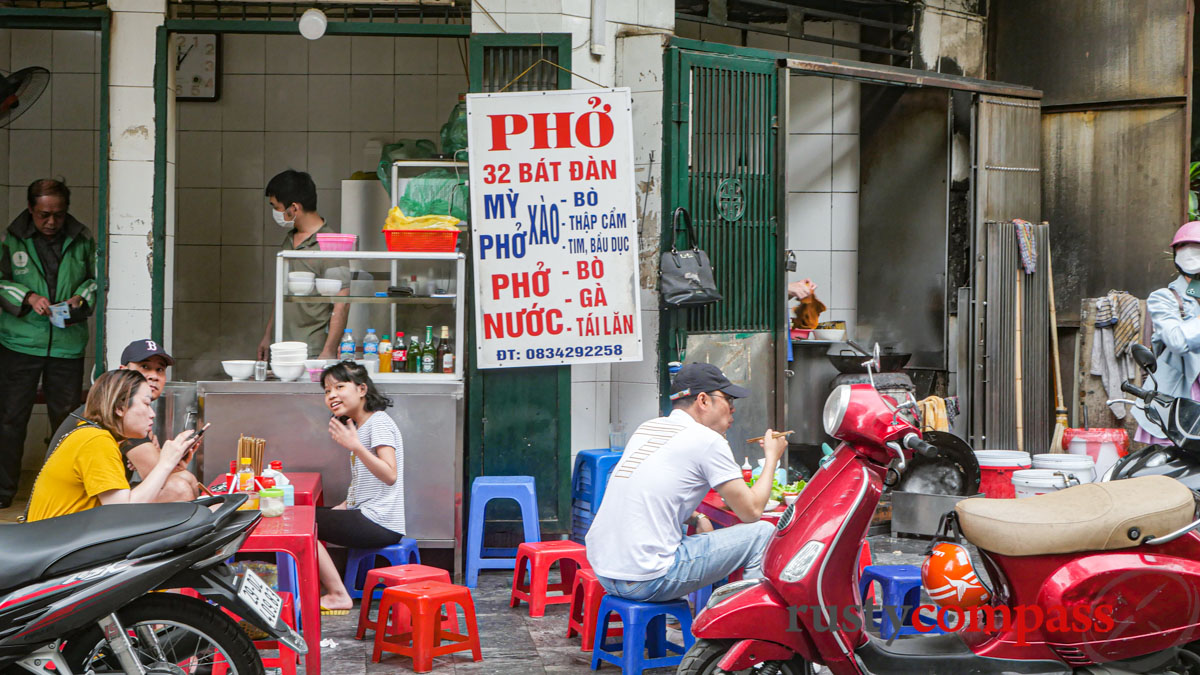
678, 365, 1200, 675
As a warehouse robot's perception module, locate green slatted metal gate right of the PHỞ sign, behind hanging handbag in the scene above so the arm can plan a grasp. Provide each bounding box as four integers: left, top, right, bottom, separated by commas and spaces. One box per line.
660, 40, 784, 393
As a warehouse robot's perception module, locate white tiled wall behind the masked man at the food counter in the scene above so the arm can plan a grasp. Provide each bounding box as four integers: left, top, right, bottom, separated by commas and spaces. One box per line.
169, 35, 468, 380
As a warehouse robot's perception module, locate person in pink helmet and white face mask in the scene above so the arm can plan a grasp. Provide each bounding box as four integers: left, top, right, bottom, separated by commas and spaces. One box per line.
1129, 220, 1200, 446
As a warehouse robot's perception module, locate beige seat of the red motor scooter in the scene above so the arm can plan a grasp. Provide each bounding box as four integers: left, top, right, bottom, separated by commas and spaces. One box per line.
954, 476, 1195, 556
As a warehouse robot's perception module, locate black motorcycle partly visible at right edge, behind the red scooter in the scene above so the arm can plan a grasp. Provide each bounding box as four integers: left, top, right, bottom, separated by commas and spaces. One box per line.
1102, 345, 1200, 490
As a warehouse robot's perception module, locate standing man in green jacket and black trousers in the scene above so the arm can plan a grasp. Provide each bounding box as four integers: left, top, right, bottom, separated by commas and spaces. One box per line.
0, 179, 96, 508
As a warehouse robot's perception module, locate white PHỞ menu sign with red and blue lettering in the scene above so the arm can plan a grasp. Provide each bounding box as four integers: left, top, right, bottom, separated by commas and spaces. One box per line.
467, 88, 642, 368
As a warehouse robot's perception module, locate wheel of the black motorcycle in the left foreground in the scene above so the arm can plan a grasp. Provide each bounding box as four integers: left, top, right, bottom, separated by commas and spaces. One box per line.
62, 593, 264, 675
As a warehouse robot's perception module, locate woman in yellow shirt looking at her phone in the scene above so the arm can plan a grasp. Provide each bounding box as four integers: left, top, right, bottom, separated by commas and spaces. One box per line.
26, 370, 193, 522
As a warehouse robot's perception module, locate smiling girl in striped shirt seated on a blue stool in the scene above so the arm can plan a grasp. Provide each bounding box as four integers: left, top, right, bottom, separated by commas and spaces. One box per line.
317, 362, 404, 614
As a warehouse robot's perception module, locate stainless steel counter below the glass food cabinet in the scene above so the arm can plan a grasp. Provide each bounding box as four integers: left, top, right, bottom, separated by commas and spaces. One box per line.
197, 376, 464, 548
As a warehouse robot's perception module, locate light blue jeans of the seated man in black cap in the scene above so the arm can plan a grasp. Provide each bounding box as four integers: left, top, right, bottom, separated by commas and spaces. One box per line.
596, 521, 775, 602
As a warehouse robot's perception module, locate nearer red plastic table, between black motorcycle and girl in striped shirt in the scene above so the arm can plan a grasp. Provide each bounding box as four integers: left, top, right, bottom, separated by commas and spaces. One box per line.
239, 506, 320, 675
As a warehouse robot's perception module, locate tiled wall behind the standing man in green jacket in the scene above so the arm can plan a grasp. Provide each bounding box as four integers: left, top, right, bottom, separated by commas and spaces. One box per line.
0, 29, 100, 470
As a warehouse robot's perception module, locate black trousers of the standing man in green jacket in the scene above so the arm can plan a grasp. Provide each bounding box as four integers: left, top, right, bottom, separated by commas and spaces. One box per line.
0, 346, 83, 503
